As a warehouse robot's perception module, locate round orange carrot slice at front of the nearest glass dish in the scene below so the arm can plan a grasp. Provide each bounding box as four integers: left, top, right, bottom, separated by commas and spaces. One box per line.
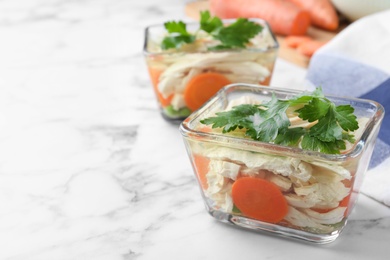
232, 177, 288, 223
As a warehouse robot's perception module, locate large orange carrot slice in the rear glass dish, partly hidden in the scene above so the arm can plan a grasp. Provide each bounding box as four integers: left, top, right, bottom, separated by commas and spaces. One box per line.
184, 72, 231, 111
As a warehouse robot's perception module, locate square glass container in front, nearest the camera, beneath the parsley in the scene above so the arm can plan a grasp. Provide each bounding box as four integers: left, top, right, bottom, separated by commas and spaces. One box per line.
180, 84, 384, 243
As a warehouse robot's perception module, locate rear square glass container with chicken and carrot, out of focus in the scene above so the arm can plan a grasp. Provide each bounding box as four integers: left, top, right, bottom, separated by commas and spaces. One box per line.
144, 19, 279, 122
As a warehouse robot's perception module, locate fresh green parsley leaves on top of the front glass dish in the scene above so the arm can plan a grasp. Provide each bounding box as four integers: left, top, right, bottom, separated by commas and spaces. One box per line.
201, 88, 359, 154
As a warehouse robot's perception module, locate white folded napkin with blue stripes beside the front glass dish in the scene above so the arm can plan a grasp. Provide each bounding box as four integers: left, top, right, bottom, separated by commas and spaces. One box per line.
306, 10, 390, 206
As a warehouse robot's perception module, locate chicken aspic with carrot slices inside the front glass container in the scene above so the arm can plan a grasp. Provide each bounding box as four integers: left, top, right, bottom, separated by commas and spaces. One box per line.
190, 96, 368, 234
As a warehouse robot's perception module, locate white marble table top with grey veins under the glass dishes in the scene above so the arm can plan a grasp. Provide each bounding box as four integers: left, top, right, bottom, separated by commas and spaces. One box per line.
0, 0, 390, 260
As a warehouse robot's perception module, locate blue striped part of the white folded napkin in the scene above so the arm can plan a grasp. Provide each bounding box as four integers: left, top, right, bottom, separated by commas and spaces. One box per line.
307, 54, 390, 169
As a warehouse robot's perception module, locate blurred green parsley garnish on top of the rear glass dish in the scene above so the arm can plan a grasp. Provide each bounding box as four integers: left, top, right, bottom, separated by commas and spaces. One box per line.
161, 11, 263, 50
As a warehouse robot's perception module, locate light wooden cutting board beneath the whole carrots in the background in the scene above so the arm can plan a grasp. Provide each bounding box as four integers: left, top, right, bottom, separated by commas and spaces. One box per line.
185, 0, 345, 68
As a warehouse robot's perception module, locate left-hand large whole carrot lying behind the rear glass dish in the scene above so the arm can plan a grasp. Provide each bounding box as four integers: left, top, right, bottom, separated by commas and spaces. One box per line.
209, 0, 310, 35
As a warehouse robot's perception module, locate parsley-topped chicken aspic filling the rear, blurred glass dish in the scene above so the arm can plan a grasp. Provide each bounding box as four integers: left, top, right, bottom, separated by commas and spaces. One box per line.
145, 10, 278, 119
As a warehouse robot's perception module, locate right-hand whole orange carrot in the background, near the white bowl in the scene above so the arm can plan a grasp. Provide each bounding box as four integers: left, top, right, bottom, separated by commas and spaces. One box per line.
288, 0, 339, 31
